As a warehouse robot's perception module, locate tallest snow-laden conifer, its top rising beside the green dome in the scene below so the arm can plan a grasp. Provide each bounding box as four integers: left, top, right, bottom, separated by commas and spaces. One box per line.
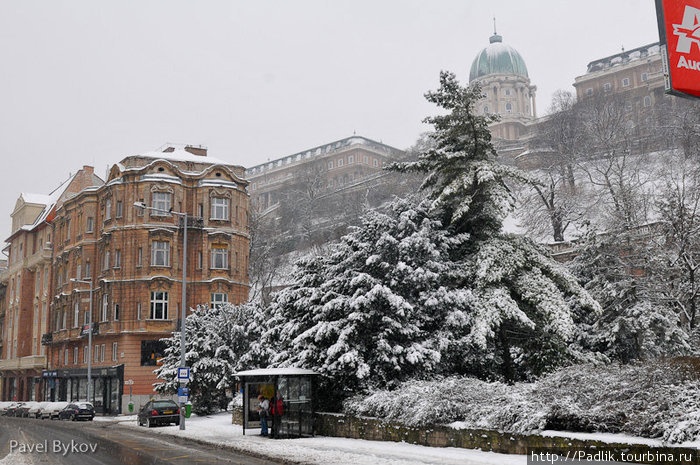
390, 72, 600, 381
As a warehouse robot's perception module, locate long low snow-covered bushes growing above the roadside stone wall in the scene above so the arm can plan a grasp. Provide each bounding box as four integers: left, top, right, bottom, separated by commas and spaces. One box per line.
344, 361, 700, 443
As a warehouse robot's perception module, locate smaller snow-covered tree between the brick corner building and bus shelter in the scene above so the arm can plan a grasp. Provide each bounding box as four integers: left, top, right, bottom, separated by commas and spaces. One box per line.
154, 304, 265, 414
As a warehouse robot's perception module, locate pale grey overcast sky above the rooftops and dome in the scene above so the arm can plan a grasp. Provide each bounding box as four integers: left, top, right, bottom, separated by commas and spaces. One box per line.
0, 0, 658, 245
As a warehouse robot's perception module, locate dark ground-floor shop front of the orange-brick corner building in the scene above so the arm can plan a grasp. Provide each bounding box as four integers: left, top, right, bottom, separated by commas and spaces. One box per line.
42, 365, 124, 415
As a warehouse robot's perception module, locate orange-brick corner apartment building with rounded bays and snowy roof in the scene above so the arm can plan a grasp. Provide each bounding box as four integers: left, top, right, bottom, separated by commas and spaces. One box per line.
0, 146, 249, 414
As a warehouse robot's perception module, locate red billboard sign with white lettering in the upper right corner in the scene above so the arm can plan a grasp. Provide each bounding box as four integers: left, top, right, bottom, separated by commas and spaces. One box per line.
656, 0, 700, 97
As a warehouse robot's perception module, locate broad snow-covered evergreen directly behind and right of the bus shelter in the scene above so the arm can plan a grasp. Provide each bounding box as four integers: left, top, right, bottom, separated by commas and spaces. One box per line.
262, 200, 466, 404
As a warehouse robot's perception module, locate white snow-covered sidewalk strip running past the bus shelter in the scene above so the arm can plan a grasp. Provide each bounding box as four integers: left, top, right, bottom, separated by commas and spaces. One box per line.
120, 412, 526, 465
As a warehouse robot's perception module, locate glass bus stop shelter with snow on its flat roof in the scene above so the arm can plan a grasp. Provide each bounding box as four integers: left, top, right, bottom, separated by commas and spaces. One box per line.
236, 368, 318, 438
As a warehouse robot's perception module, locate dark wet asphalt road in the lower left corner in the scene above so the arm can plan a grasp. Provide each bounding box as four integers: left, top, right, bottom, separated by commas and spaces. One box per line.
0, 417, 279, 465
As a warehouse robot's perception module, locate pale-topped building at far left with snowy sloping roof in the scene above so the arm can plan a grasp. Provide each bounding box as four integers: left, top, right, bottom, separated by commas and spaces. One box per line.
0, 166, 102, 400
